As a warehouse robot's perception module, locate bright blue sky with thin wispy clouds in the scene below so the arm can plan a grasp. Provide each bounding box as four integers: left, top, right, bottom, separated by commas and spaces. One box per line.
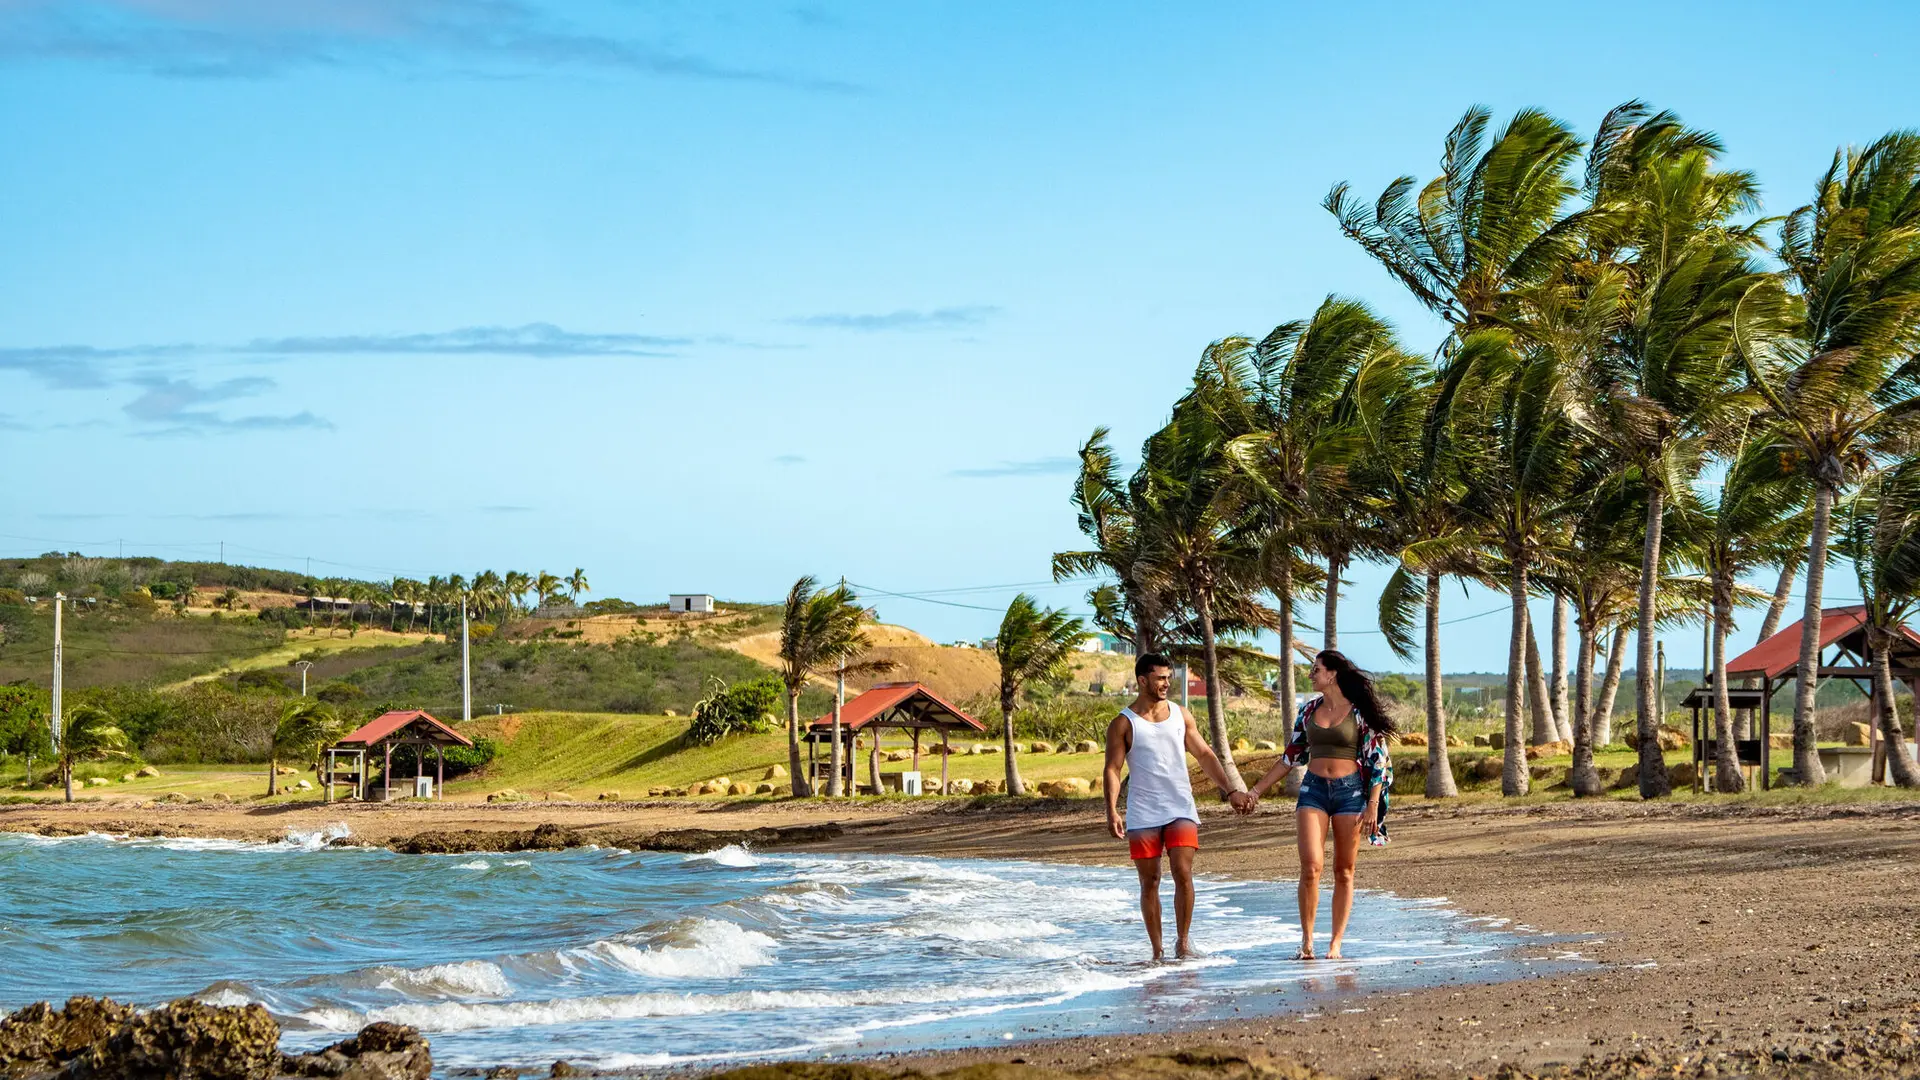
0, 0, 1920, 671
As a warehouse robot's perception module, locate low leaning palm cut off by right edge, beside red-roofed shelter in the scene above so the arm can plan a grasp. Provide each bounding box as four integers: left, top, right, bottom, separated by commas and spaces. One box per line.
1836, 457, 1920, 788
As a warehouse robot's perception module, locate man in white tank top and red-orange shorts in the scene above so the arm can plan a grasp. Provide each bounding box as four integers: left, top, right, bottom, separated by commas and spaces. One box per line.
1102, 653, 1250, 963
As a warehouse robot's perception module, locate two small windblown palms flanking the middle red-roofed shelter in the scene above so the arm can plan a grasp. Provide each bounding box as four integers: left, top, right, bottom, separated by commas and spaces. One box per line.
780, 577, 1087, 798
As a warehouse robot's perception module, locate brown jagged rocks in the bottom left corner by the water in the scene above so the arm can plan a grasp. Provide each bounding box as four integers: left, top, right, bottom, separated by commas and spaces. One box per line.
0, 997, 422, 1080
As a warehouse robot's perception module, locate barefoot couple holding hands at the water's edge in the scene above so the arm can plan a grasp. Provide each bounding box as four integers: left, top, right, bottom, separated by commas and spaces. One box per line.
1102, 650, 1394, 961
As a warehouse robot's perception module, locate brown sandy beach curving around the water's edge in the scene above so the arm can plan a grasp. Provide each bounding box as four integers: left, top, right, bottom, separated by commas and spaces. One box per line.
0, 801, 1920, 1076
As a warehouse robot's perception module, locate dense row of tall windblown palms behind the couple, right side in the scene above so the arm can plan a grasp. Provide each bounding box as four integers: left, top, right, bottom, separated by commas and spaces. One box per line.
1054, 102, 1920, 798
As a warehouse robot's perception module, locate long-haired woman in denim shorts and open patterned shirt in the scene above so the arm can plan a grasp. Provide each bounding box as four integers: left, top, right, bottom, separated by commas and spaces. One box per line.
1242, 650, 1394, 961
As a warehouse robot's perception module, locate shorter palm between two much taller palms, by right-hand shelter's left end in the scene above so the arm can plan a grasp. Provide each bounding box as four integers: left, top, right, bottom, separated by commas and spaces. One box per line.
1680, 434, 1807, 792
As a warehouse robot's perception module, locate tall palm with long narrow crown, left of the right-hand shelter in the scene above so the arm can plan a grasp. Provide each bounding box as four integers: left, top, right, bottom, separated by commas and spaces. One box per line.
1584, 102, 1764, 798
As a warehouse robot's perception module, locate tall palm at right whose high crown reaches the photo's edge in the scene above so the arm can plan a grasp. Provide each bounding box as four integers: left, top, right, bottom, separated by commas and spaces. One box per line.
1740, 131, 1920, 784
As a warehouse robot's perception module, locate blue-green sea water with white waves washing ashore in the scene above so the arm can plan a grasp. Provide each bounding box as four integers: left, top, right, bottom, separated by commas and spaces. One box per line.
0, 826, 1542, 1070
